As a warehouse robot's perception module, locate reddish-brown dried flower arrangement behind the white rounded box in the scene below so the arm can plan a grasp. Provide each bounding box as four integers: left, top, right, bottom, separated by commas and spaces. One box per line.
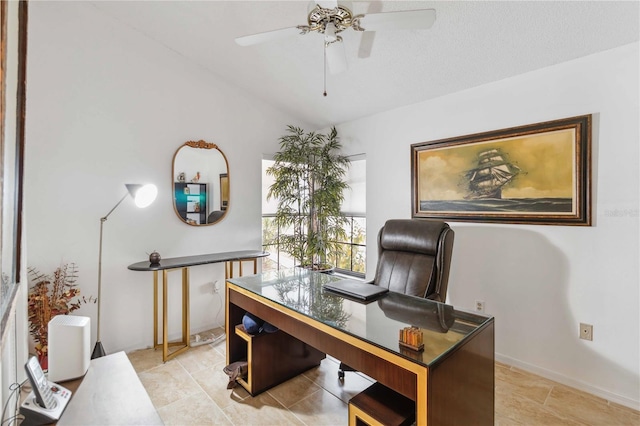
27, 263, 98, 358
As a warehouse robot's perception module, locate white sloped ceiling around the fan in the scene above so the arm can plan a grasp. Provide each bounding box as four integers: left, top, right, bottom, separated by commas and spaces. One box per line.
92, 0, 640, 128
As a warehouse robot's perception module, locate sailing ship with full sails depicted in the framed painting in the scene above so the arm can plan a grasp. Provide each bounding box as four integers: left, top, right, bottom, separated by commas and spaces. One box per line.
464, 148, 520, 200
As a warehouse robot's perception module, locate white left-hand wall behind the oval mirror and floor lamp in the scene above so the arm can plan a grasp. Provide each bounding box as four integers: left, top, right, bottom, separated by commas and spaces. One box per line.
25, 2, 312, 353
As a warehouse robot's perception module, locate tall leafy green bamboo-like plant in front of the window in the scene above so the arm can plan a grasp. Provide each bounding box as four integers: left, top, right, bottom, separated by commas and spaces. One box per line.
267, 126, 350, 270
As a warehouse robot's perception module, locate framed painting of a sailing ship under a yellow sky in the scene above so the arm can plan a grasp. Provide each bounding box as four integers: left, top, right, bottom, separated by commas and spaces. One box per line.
411, 115, 591, 226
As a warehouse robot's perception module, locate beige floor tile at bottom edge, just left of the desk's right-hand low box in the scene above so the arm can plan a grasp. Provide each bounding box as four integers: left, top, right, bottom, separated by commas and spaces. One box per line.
289, 390, 349, 426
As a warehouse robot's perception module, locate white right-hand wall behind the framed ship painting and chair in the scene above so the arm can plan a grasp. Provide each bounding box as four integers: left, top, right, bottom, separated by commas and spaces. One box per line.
338, 43, 640, 409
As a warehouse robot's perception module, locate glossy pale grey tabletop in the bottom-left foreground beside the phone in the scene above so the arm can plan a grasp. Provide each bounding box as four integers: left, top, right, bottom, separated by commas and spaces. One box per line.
38, 352, 163, 426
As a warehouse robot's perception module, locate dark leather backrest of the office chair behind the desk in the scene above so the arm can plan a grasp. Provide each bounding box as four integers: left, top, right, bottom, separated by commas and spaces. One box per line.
373, 219, 454, 302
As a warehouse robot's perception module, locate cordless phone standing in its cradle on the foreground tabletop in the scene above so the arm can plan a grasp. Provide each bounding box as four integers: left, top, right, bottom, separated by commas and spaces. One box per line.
20, 356, 71, 424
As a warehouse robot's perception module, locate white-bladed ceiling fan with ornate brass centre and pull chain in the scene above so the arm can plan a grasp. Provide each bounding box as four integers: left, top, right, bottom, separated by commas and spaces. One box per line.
236, 0, 436, 96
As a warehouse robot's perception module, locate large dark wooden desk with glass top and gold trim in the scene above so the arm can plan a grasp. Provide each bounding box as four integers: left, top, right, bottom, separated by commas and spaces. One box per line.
226, 268, 494, 425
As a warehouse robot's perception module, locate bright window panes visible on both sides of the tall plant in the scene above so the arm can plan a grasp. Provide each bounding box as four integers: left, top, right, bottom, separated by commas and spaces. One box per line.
262, 156, 367, 277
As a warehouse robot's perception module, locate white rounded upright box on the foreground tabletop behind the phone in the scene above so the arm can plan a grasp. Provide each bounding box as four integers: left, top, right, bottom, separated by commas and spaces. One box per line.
48, 315, 91, 382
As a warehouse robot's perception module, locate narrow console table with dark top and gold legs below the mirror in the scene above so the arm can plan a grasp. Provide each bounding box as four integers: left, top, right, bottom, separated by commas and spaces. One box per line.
128, 250, 269, 362
